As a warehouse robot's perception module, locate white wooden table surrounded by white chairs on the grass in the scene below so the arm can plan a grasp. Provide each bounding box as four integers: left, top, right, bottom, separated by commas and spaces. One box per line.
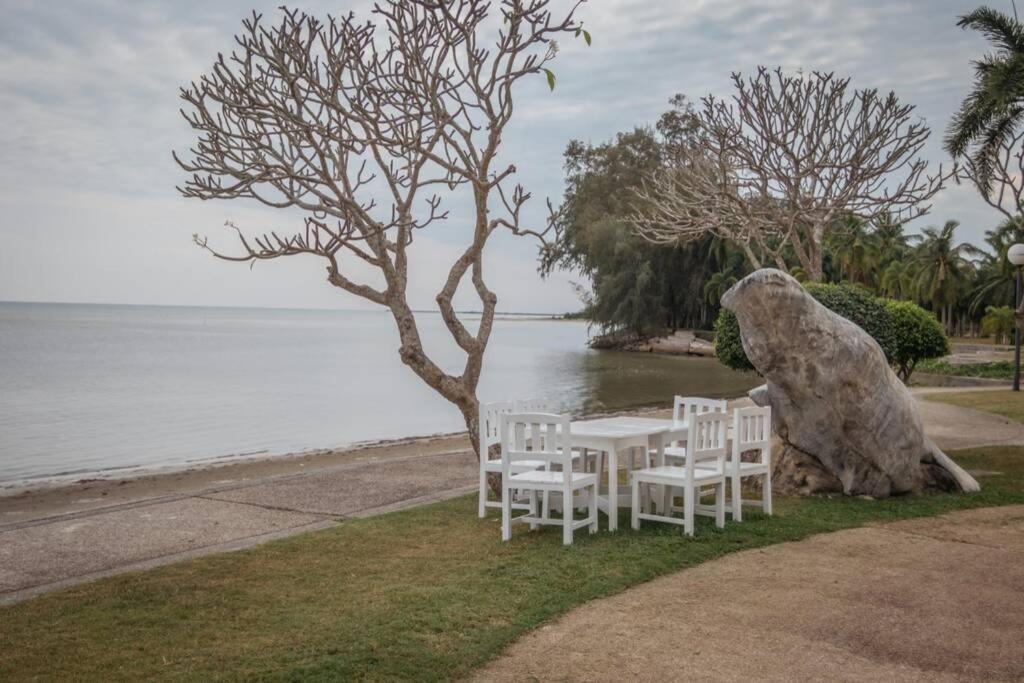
569, 417, 686, 531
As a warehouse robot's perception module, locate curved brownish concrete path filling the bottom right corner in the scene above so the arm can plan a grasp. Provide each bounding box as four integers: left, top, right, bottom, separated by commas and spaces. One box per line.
476, 506, 1024, 681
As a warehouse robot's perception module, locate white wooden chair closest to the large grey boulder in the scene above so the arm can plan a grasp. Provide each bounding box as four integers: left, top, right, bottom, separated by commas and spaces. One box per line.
724, 405, 771, 521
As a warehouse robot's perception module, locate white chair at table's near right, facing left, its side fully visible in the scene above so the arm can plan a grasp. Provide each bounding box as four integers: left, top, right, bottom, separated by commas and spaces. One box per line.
630, 413, 728, 536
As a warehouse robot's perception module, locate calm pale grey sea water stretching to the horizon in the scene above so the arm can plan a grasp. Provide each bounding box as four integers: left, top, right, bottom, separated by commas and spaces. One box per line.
0, 303, 755, 483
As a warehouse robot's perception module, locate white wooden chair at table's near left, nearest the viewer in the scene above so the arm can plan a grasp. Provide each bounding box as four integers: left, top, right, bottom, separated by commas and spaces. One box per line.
499, 413, 597, 546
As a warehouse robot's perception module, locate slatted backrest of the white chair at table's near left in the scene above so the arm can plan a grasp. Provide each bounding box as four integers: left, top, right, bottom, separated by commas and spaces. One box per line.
501, 413, 572, 482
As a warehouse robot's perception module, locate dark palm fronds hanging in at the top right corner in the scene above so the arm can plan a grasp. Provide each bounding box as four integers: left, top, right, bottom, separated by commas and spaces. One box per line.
945, 7, 1024, 198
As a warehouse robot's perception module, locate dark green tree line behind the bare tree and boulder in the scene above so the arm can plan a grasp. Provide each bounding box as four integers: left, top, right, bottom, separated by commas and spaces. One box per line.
542, 95, 1024, 340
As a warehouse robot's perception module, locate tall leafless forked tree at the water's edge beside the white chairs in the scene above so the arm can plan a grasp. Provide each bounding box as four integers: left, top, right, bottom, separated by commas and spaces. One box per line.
175, 0, 590, 458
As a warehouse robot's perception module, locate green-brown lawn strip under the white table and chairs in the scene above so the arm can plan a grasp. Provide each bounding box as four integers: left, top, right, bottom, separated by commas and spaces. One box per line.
0, 444, 1024, 680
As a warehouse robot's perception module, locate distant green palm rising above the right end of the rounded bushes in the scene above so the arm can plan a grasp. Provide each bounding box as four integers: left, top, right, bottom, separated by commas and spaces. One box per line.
913, 220, 982, 332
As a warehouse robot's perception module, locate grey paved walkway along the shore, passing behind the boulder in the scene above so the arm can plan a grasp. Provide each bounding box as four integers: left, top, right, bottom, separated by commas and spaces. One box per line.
0, 389, 1024, 603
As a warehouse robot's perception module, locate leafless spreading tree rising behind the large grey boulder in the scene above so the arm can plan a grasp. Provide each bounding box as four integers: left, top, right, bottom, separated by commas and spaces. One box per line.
633, 67, 949, 281
